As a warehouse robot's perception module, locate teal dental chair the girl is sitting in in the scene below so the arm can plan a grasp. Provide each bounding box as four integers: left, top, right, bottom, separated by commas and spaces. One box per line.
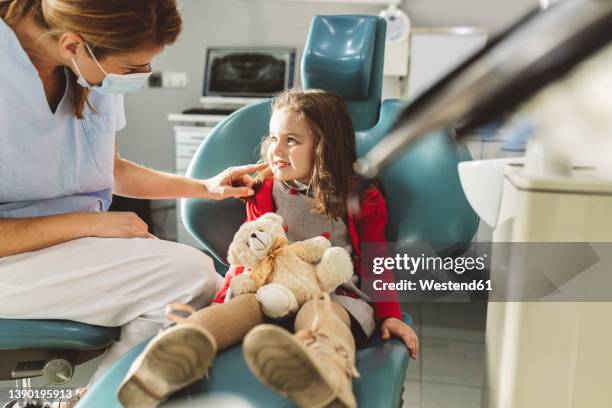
78, 16, 478, 408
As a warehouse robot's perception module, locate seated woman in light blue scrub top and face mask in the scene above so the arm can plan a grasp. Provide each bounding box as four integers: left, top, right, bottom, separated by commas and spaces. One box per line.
0, 0, 261, 388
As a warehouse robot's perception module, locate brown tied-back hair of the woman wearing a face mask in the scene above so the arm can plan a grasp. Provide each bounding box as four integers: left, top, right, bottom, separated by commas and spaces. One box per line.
0, 0, 182, 118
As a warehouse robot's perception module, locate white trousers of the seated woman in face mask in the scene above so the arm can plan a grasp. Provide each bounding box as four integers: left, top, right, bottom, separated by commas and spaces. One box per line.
0, 238, 222, 383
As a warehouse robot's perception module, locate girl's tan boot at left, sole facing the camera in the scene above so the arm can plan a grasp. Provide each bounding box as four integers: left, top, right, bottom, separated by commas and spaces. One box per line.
117, 304, 217, 408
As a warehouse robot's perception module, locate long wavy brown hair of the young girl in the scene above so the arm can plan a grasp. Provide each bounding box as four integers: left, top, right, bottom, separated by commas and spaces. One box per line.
257, 89, 357, 218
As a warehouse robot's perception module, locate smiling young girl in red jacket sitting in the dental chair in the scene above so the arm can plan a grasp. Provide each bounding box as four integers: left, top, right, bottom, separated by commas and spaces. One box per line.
119, 90, 418, 408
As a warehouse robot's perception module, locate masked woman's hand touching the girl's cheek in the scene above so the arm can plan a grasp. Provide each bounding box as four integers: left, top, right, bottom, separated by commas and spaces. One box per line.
201, 163, 268, 200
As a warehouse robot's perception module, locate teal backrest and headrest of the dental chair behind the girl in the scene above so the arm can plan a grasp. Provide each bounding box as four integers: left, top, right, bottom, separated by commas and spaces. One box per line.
182, 16, 478, 270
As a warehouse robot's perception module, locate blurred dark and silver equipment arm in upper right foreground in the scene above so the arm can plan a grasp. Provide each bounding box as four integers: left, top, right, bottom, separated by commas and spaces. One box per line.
356, 0, 612, 178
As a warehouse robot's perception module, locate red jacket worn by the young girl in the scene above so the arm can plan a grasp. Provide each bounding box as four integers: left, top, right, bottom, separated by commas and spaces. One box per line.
214, 178, 402, 320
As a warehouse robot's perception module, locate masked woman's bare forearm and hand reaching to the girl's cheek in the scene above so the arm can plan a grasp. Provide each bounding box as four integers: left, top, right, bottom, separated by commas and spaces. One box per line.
114, 153, 267, 200
